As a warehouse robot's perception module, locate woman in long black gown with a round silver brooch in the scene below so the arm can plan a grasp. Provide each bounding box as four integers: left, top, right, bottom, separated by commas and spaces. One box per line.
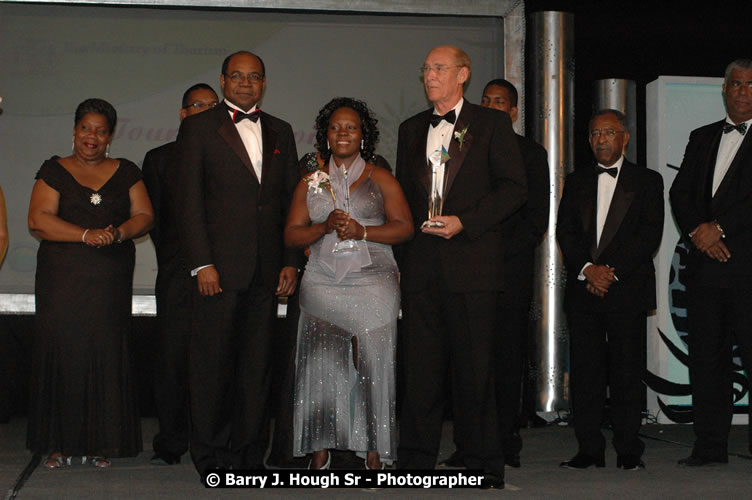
27, 99, 154, 468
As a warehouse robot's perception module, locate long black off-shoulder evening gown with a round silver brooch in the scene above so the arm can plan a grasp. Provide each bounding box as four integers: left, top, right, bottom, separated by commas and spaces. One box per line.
27, 157, 142, 457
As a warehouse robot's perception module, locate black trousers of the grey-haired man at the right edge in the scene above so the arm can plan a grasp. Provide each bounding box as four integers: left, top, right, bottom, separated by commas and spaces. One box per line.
687, 284, 752, 462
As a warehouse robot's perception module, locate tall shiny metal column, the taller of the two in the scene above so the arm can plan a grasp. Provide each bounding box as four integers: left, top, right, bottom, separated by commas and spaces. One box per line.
526, 12, 574, 412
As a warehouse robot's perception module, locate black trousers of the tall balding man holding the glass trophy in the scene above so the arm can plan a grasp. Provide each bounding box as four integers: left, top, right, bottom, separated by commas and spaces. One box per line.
397, 279, 504, 477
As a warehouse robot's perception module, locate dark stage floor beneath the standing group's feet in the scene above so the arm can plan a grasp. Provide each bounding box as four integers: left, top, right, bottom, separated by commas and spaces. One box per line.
0, 418, 752, 500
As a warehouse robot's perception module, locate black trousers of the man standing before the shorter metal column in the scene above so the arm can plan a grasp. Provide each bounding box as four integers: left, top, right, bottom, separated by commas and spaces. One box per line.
567, 311, 647, 458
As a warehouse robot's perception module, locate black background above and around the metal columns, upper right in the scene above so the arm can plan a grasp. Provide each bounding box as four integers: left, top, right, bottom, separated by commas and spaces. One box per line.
525, 0, 752, 168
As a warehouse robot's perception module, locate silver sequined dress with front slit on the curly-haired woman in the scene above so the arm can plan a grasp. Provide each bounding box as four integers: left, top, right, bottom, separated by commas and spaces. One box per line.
294, 172, 400, 463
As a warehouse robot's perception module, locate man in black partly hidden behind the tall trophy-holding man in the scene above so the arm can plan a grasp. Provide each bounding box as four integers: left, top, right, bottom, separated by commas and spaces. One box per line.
480, 78, 551, 467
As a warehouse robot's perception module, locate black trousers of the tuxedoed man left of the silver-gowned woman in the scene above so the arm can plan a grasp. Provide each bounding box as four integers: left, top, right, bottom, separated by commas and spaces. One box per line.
190, 286, 277, 475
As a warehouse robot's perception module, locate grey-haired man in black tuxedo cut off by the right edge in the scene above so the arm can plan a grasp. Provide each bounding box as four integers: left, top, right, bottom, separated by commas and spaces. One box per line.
670, 59, 752, 466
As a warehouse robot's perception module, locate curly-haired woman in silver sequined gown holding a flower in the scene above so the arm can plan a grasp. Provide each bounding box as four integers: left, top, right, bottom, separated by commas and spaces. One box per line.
285, 98, 413, 469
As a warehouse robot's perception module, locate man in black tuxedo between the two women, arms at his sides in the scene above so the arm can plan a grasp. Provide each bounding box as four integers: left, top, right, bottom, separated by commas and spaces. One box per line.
170, 51, 299, 476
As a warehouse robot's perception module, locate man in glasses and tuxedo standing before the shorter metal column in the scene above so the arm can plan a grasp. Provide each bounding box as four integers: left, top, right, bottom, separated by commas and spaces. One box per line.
556, 109, 663, 470
